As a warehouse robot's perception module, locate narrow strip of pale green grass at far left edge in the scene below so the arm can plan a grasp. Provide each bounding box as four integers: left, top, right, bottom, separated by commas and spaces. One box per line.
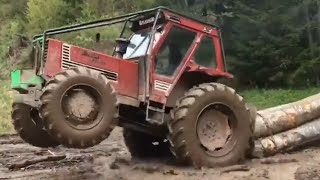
0, 81, 13, 134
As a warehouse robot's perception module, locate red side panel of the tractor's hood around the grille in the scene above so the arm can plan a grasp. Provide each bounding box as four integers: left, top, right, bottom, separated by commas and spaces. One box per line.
45, 39, 139, 99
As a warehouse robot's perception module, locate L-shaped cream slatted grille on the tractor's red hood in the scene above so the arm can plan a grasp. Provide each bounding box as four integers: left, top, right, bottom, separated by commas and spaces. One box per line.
61, 44, 118, 82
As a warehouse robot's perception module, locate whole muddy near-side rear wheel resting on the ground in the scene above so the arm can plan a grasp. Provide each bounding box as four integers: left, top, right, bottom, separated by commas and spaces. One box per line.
168, 83, 252, 168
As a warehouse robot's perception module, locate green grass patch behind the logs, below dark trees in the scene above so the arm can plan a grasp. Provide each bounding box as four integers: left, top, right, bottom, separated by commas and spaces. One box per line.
240, 88, 320, 109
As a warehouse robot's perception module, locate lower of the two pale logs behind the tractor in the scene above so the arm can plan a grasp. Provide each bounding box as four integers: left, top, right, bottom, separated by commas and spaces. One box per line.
252, 118, 320, 157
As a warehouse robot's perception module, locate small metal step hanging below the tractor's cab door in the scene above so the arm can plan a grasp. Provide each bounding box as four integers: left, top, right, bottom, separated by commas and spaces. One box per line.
146, 102, 166, 125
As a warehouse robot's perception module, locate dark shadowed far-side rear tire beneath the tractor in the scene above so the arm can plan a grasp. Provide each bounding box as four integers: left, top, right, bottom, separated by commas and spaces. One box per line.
123, 128, 172, 159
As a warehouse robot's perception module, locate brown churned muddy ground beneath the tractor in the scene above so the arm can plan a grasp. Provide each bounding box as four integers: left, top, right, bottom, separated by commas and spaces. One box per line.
0, 128, 320, 180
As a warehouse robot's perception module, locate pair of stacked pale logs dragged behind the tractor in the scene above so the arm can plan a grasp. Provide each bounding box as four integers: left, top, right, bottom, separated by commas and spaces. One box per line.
252, 94, 320, 157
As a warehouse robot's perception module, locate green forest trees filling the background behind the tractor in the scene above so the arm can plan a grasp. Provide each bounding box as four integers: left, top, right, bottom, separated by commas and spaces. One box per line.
0, 0, 320, 88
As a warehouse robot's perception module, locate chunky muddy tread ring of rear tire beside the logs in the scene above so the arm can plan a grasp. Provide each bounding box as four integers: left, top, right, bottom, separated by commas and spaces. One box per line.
167, 83, 252, 167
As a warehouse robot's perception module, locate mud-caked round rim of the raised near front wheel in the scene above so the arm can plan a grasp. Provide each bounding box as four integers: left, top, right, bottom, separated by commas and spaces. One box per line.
61, 84, 103, 130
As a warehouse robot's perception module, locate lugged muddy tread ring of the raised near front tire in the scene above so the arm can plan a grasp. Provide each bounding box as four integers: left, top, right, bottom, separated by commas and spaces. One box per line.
40, 67, 118, 149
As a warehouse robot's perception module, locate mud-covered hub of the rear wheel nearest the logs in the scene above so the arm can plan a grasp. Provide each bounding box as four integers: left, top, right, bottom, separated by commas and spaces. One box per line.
197, 104, 231, 152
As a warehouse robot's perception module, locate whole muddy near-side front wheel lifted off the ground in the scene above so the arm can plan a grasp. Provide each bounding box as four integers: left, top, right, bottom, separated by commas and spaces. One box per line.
40, 67, 118, 149
